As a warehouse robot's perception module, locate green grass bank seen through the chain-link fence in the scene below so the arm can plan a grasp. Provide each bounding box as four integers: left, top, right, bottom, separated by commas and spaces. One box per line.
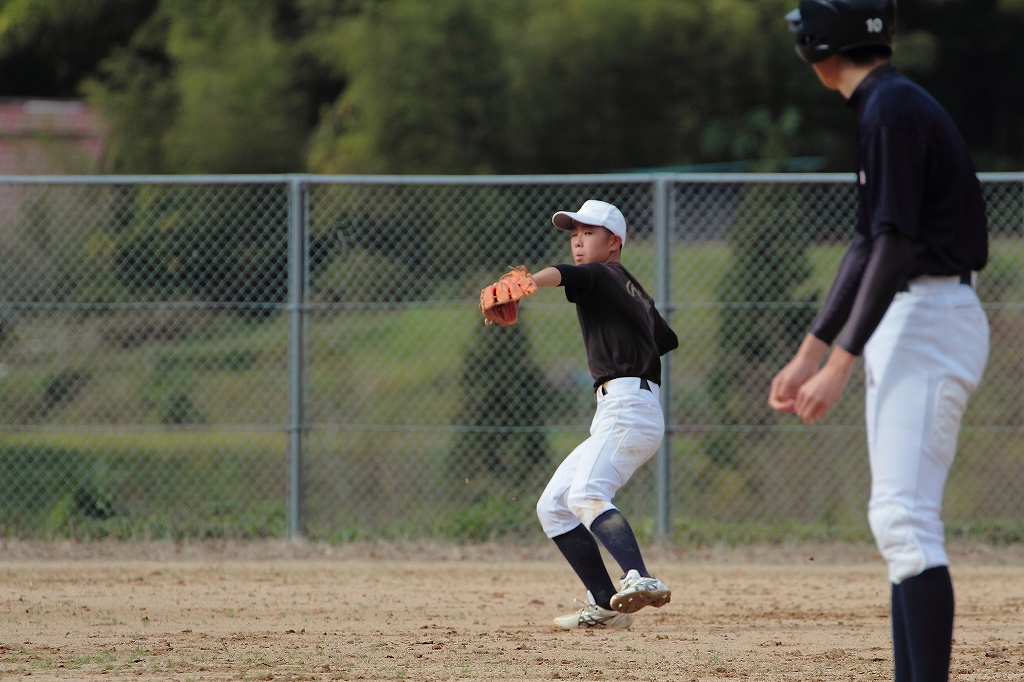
0, 241, 1024, 544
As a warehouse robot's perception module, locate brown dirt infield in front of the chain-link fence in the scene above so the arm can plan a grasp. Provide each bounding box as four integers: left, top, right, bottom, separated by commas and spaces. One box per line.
0, 546, 1024, 681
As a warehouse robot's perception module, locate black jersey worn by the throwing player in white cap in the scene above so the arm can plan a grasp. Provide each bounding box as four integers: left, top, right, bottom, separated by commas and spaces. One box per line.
555, 263, 679, 389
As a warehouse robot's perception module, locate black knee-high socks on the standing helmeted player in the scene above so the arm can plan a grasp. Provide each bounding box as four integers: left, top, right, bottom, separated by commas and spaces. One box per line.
893, 566, 953, 682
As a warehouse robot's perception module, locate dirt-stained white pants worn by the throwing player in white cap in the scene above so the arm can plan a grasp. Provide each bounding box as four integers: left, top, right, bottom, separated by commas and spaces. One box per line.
537, 377, 665, 538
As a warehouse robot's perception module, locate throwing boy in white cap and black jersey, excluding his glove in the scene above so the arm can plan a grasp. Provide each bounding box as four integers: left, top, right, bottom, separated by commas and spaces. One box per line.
481, 201, 679, 630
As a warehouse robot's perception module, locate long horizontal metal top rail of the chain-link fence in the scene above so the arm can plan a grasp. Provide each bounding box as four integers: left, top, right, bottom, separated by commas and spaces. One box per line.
0, 172, 1024, 185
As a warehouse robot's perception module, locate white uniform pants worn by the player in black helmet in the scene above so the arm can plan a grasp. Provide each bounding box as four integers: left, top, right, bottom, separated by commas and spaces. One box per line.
864, 278, 988, 584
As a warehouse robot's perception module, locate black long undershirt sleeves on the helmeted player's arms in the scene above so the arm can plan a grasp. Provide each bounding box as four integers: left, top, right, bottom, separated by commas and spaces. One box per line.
811, 232, 913, 355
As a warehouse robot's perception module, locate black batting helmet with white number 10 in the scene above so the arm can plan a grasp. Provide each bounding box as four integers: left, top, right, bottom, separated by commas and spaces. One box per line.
785, 0, 896, 63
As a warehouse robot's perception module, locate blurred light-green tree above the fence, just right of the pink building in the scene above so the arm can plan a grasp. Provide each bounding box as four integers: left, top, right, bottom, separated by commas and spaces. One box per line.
76, 0, 354, 173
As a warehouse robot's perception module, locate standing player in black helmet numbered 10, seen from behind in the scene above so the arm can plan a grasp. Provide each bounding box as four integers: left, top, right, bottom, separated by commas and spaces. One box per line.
769, 0, 988, 682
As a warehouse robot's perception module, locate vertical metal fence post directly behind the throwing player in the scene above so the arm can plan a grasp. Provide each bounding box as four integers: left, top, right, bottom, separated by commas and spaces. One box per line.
652, 177, 672, 541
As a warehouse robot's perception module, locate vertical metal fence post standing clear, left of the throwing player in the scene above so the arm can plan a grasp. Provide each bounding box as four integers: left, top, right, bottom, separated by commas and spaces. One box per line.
286, 177, 307, 540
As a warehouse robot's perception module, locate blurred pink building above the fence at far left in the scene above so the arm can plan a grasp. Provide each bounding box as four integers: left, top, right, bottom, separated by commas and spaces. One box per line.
0, 98, 106, 175
